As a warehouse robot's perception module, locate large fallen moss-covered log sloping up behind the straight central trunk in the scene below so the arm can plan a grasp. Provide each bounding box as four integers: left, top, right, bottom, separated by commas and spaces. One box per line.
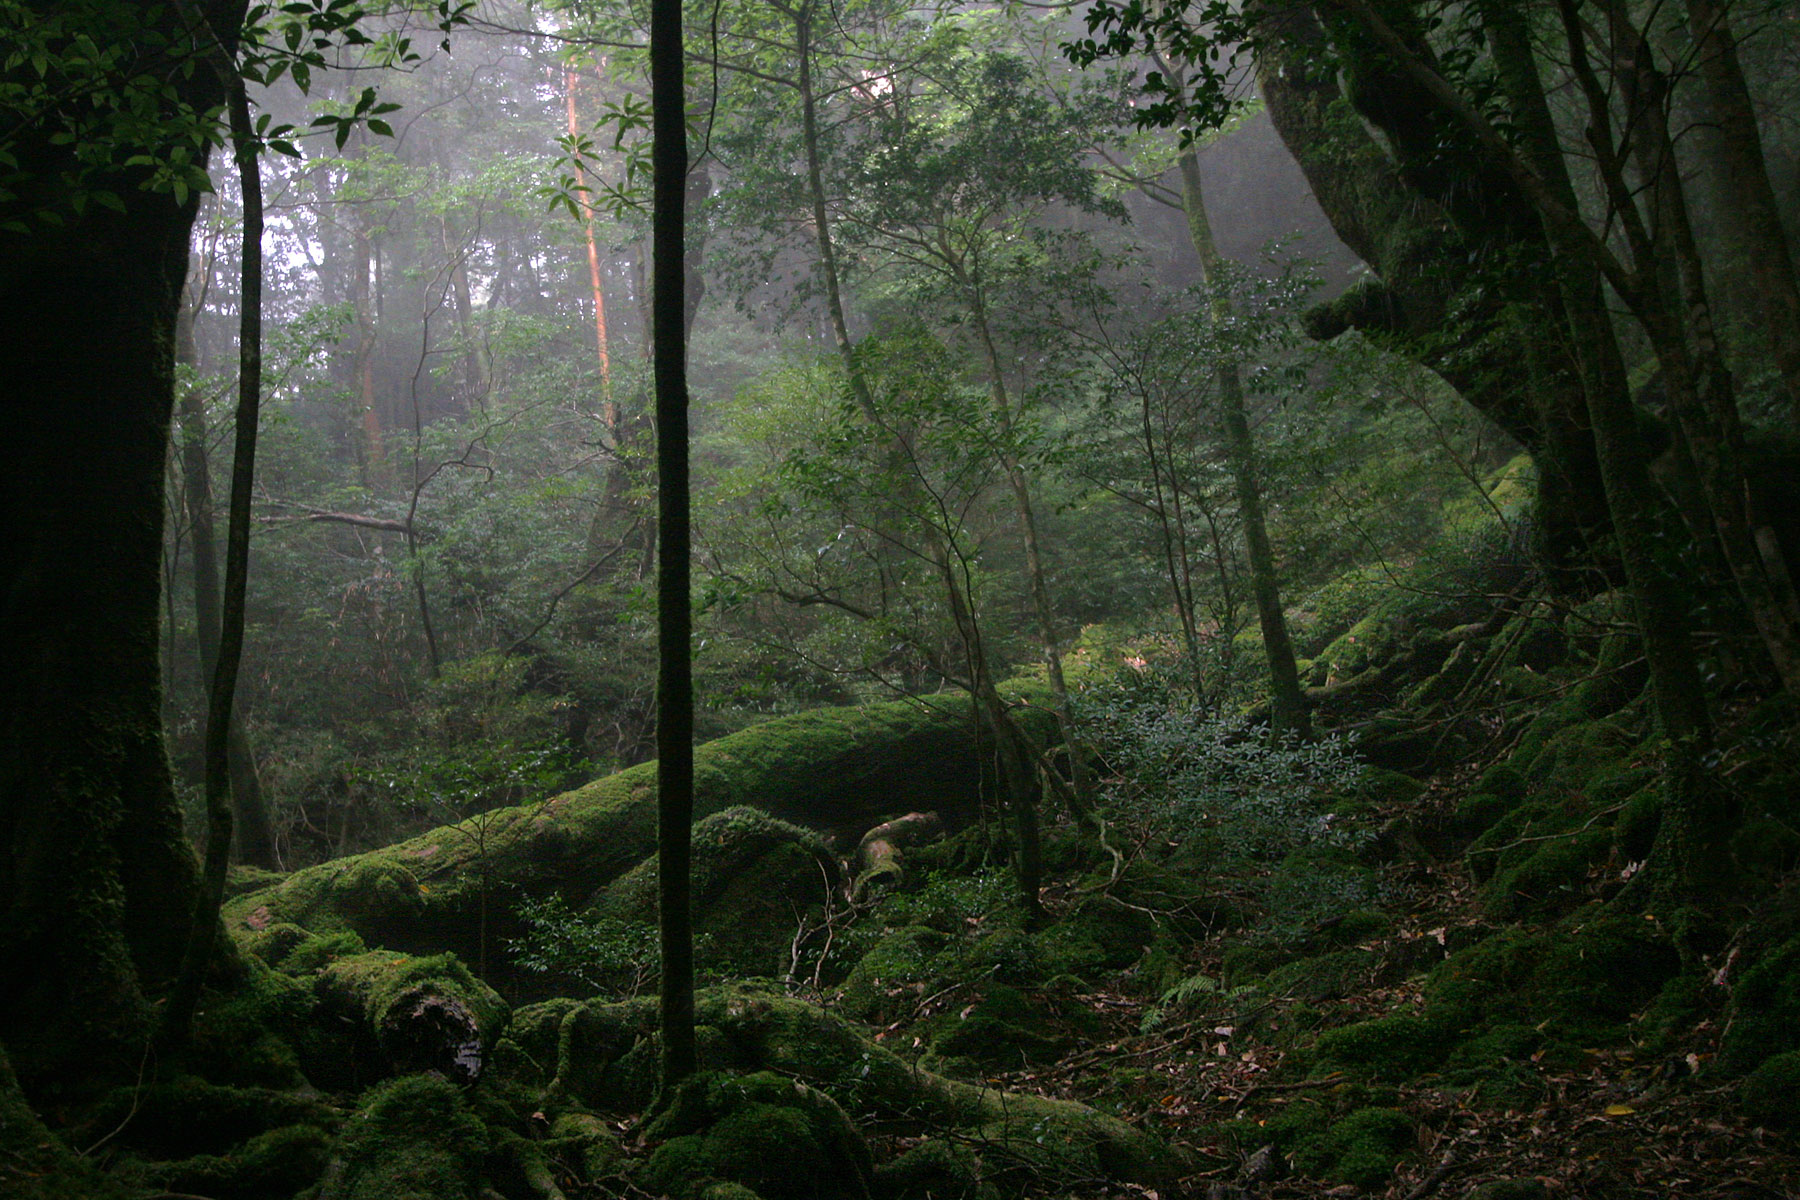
225, 702, 979, 961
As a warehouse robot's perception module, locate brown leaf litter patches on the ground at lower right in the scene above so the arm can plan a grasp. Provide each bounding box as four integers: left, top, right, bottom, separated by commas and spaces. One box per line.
943, 784, 1800, 1200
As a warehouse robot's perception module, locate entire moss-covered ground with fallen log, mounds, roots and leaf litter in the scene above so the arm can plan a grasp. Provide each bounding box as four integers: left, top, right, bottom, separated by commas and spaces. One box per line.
0, 471, 1800, 1200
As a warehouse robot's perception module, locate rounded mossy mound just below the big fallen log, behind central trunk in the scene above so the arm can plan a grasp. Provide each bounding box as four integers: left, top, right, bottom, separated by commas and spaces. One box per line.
589, 804, 841, 977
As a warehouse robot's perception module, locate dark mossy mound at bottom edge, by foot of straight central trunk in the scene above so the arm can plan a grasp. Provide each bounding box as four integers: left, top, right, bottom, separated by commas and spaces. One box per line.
641, 1070, 873, 1200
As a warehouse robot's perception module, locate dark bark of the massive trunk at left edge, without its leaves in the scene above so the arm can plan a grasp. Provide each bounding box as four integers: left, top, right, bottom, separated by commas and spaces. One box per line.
0, 4, 241, 1088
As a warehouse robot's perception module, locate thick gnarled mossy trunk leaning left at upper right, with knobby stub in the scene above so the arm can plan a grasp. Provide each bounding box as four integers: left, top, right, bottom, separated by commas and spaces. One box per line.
1256, 0, 1609, 592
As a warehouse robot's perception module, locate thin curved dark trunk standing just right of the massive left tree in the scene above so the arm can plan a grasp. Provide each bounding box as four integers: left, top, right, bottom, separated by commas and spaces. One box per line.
162, 70, 263, 1042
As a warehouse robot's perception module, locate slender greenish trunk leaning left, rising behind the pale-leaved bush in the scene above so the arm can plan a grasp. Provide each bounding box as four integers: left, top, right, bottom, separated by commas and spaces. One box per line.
1179, 148, 1312, 738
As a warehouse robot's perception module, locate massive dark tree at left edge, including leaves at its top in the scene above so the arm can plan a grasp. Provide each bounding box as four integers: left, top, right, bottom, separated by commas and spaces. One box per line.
0, 0, 464, 1087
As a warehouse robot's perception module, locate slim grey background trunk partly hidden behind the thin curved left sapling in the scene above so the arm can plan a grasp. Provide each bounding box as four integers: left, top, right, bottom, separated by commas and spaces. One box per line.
175, 286, 279, 869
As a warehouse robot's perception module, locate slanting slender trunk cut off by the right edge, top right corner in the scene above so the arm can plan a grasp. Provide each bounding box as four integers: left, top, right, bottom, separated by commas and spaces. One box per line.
1687, 0, 1800, 419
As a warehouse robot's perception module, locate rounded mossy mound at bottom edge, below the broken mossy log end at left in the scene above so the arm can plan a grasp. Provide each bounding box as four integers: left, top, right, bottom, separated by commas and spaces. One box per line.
331, 1074, 488, 1200
